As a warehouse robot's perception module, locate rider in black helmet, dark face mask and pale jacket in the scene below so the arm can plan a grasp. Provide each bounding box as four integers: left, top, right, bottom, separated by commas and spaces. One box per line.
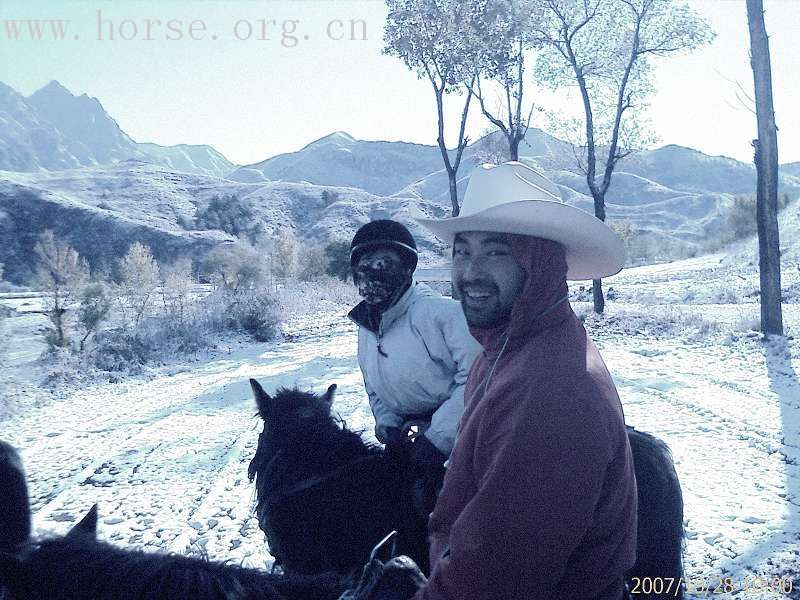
349, 219, 479, 518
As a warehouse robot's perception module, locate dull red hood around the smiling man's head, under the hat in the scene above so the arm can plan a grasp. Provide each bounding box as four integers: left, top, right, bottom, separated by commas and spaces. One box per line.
470, 234, 572, 350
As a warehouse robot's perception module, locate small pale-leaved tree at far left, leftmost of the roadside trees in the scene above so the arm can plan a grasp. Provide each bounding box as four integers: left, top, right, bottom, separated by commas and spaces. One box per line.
36, 229, 89, 348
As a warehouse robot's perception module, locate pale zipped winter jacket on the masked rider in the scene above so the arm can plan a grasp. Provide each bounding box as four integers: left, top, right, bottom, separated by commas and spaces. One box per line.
349, 283, 481, 455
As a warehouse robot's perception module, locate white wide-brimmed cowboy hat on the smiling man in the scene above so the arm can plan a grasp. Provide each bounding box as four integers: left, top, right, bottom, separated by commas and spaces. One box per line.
416, 162, 625, 279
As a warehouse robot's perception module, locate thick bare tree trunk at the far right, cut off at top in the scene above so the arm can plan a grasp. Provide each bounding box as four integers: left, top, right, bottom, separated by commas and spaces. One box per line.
747, 0, 783, 335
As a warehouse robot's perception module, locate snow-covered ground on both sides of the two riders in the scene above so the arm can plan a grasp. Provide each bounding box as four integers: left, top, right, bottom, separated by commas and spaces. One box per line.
0, 257, 800, 598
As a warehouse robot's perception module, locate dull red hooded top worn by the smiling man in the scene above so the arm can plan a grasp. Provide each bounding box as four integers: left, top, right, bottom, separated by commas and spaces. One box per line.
415, 236, 636, 600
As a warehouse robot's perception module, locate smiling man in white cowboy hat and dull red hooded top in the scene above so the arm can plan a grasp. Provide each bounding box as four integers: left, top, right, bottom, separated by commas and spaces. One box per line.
406, 162, 636, 600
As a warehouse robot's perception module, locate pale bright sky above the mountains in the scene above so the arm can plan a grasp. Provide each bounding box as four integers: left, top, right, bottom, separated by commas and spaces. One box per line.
0, 0, 800, 164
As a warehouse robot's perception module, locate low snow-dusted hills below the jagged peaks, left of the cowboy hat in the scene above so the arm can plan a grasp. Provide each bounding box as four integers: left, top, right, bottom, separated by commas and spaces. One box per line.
0, 161, 450, 283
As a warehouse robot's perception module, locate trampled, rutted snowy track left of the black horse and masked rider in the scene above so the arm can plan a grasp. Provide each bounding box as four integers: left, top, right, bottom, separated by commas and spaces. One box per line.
2, 312, 368, 567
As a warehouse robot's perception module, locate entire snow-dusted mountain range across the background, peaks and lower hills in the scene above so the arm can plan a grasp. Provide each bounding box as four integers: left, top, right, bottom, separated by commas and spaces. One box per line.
0, 82, 800, 282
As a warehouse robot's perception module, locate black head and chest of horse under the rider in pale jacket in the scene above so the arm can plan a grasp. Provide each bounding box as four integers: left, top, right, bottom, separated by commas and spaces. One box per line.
248, 379, 427, 573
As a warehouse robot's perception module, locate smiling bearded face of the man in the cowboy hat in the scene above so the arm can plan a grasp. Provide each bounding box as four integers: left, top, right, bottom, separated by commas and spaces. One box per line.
453, 231, 527, 329
